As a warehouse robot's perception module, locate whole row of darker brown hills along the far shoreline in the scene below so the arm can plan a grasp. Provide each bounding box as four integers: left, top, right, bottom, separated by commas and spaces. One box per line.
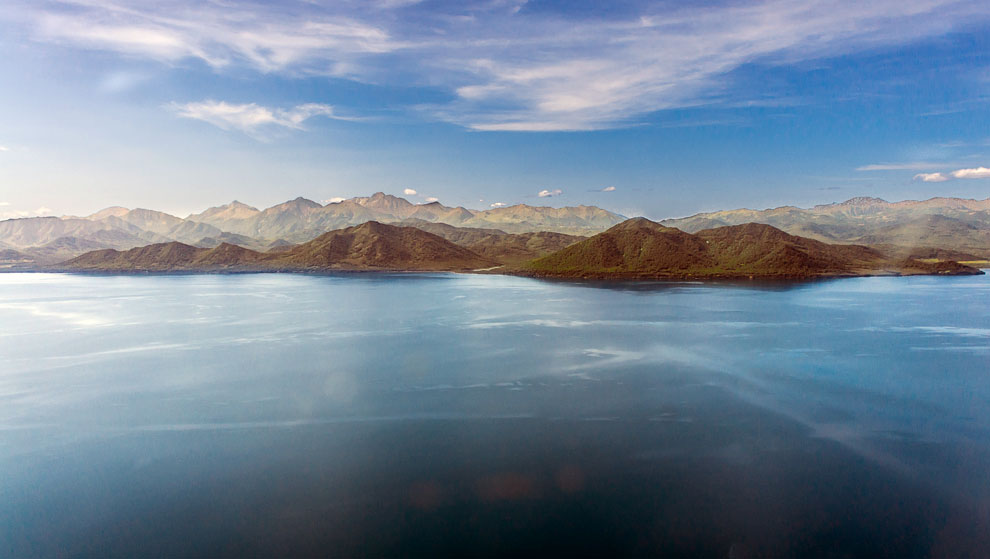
59, 218, 981, 279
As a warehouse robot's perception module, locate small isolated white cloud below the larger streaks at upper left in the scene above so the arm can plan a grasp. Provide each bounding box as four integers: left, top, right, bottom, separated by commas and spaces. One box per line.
169, 99, 340, 134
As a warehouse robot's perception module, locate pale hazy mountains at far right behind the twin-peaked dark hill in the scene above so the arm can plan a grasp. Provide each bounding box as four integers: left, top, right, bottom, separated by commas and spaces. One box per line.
661, 197, 990, 258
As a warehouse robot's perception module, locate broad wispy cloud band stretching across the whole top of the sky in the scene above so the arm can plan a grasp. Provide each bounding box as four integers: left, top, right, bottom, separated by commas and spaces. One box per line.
9, 0, 990, 131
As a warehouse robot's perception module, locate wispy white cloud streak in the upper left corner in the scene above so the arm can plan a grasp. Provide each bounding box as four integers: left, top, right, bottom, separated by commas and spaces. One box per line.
29, 0, 401, 74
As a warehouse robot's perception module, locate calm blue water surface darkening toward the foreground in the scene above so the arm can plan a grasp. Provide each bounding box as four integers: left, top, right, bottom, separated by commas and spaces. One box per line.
0, 274, 990, 559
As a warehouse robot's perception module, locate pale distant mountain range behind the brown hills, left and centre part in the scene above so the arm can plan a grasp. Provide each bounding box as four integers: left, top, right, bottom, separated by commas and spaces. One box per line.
0, 192, 624, 264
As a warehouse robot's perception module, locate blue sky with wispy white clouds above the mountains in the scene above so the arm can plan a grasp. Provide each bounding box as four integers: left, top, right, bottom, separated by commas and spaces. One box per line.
0, 0, 990, 219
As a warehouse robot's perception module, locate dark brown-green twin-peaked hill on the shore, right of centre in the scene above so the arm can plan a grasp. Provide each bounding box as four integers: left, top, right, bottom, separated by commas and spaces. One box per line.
526, 218, 980, 278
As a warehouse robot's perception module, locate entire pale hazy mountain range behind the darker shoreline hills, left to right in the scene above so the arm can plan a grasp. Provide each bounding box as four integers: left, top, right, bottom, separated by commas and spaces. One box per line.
0, 192, 990, 274
